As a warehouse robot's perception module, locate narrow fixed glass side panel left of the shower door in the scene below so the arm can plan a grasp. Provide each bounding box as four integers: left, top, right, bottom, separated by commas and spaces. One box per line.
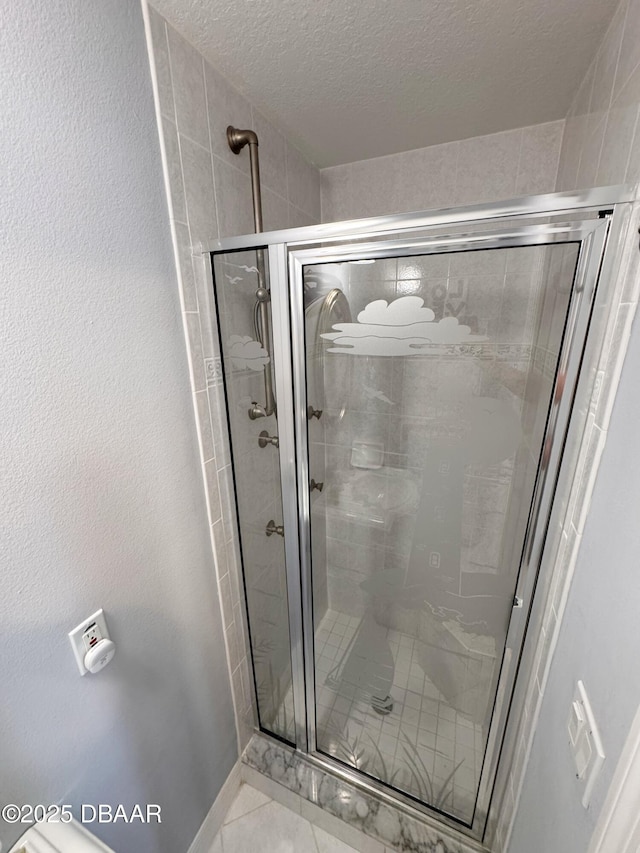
213, 250, 295, 743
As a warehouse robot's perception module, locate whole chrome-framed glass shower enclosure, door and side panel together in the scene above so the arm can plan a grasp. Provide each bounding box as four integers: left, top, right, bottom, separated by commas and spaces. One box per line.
207, 183, 629, 839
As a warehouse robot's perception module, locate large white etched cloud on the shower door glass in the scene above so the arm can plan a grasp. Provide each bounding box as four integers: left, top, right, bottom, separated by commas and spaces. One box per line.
322, 296, 487, 355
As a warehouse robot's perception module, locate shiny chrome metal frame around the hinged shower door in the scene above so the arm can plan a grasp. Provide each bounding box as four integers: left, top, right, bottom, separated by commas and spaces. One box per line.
206, 187, 633, 841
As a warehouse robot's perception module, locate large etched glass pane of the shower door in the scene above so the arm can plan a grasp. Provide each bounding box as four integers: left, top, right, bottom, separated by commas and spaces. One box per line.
304, 243, 579, 824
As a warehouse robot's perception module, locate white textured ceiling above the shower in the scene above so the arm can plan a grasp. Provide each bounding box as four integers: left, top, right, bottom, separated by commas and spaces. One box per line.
153, 0, 618, 167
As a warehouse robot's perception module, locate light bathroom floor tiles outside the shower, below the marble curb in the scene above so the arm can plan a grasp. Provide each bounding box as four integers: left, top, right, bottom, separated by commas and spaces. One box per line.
210, 784, 370, 853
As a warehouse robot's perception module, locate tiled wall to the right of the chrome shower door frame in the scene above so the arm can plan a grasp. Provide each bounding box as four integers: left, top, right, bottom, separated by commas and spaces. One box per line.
496, 0, 640, 850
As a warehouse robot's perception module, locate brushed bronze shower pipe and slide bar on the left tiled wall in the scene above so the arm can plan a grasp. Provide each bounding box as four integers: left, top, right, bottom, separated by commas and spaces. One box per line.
227, 125, 276, 421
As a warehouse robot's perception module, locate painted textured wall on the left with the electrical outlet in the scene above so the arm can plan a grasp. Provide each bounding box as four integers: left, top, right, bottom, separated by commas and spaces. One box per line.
0, 0, 237, 853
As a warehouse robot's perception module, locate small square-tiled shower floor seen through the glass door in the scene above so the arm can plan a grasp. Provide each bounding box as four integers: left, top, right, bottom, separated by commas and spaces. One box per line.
316, 610, 484, 818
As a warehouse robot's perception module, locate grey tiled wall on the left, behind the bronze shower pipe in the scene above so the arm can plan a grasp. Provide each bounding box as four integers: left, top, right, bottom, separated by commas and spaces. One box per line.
143, 4, 320, 750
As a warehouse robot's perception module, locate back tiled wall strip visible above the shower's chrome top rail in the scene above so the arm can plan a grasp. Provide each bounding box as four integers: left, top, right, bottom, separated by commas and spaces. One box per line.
321, 121, 564, 222
